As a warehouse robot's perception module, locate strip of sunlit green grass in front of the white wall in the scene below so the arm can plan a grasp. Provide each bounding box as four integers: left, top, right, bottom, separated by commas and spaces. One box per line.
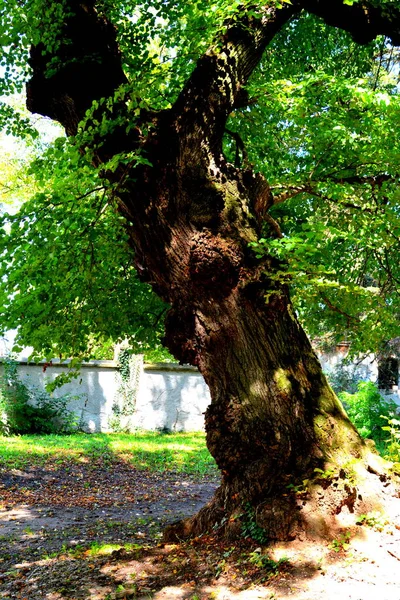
0, 432, 217, 475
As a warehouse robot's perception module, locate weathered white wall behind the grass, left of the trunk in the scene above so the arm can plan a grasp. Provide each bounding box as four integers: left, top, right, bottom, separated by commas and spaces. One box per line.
0, 361, 210, 432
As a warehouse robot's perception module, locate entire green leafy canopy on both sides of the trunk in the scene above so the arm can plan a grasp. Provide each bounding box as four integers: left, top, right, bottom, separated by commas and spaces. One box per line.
0, 0, 400, 357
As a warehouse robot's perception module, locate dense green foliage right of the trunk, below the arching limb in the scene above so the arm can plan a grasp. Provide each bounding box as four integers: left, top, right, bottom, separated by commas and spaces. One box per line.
239, 22, 400, 354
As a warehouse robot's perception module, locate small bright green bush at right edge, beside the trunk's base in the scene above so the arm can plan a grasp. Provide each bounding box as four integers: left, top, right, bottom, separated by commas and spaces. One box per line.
340, 381, 398, 444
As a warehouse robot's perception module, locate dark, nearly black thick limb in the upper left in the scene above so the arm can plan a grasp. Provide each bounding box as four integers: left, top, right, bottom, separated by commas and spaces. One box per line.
26, 0, 127, 135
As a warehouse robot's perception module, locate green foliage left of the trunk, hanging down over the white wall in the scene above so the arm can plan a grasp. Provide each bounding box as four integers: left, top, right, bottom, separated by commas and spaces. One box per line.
0, 139, 170, 366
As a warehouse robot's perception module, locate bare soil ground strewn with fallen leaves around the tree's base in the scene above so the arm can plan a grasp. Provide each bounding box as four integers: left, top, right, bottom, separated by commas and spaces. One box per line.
0, 463, 400, 600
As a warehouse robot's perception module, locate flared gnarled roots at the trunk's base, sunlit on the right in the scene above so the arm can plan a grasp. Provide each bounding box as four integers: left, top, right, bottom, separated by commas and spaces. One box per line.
164, 452, 400, 542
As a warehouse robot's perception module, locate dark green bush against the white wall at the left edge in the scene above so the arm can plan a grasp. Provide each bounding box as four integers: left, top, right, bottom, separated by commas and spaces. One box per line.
0, 359, 78, 435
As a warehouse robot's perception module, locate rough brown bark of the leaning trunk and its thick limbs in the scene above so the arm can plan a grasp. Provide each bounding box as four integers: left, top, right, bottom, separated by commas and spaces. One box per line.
28, 0, 399, 539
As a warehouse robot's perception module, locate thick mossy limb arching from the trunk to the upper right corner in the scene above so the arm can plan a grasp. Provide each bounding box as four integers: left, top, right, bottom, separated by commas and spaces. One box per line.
174, 0, 400, 156
